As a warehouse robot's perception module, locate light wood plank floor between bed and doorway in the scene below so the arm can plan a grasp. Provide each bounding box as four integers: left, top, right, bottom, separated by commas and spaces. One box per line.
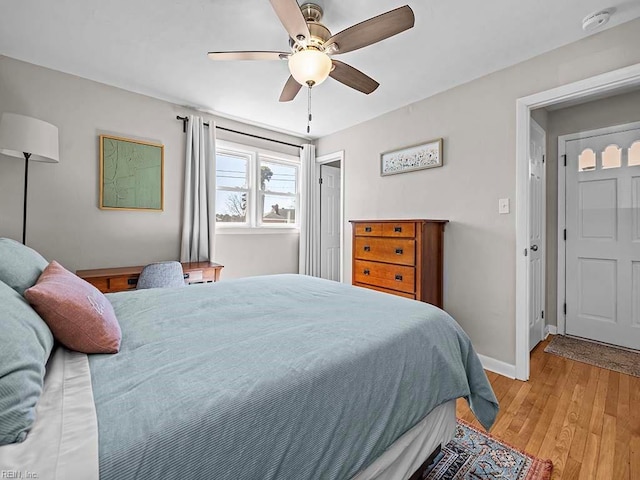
457, 340, 640, 480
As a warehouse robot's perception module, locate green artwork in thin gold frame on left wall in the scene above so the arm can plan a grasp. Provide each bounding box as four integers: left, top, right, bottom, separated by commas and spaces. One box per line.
100, 135, 164, 211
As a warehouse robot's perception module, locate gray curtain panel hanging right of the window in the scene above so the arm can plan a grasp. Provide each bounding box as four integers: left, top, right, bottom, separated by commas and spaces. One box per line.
299, 144, 320, 277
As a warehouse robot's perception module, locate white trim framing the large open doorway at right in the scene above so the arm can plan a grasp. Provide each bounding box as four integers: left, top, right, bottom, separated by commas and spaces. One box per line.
515, 63, 640, 380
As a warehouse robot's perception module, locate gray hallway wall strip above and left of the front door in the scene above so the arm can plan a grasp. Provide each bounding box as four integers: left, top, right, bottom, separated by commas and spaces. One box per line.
545, 87, 640, 325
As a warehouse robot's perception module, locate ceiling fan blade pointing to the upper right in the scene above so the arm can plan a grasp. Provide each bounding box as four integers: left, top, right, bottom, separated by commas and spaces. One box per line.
324, 5, 415, 53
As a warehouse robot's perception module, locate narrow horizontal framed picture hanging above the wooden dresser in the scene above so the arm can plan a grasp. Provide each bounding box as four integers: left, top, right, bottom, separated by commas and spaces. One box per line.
380, 138, 442, 176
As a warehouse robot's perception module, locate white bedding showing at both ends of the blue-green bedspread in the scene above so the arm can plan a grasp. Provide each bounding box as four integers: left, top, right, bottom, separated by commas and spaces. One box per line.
0, 347, 456, 480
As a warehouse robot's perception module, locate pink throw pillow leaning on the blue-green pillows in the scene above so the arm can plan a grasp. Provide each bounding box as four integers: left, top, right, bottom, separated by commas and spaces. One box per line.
24, 261, 122, 353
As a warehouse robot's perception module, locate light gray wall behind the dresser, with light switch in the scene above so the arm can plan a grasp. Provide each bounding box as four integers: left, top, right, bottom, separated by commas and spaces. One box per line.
317, 20, 640, 364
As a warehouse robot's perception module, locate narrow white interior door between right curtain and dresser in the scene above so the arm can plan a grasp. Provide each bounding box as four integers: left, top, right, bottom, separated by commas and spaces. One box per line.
320, 165, 340, 282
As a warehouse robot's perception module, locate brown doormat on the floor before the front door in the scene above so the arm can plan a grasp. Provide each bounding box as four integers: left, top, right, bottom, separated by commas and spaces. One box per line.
544, 335, 640, 377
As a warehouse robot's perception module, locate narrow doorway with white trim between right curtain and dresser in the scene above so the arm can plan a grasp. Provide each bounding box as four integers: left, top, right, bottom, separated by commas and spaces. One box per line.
316, 152, 344, 282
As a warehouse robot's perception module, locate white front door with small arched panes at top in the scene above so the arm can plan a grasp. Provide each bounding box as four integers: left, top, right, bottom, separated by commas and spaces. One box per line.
565, 126, 640, 349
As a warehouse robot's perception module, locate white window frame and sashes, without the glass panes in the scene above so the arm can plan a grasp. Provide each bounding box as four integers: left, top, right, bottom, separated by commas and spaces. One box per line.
216, 140, 300, 234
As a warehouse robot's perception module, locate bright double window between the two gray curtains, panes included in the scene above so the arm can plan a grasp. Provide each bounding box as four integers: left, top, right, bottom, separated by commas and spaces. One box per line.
216, 142, 300, 228
